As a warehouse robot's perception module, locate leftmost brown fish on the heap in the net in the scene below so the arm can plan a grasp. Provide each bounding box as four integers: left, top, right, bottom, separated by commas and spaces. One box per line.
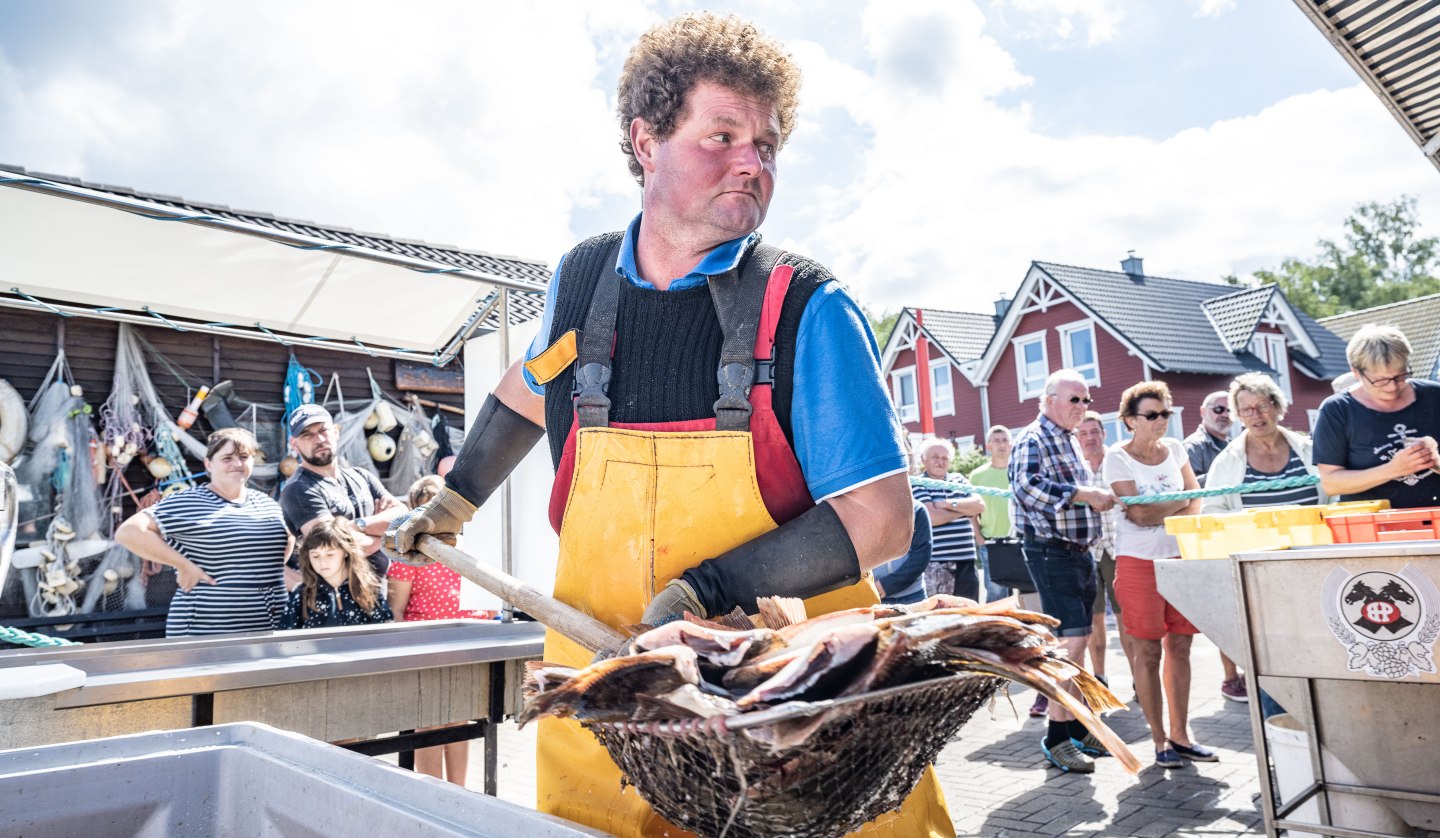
516, 646, 700, 726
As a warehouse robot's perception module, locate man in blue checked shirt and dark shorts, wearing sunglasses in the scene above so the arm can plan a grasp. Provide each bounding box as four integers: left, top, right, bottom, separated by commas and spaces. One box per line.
1009, 370, 1116, 773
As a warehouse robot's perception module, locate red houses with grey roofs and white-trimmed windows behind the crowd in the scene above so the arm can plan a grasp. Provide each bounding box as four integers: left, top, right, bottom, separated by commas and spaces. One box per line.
883, 255, 1348, 446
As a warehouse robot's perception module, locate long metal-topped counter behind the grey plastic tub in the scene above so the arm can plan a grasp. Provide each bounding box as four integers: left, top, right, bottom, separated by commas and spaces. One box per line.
0, 621, 544, 790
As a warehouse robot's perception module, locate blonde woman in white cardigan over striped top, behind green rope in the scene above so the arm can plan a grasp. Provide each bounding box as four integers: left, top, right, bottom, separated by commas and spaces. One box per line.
1201, 373, 1329, 514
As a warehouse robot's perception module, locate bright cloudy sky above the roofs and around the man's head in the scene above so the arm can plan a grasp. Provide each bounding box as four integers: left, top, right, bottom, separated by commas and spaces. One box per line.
0, 0, 1440, 318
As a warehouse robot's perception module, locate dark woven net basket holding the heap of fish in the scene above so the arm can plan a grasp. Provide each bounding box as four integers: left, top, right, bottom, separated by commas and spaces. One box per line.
588, 674, 1005, 838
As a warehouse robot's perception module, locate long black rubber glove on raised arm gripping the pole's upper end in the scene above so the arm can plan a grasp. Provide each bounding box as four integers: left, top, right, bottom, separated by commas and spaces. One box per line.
384, 393, 544, 563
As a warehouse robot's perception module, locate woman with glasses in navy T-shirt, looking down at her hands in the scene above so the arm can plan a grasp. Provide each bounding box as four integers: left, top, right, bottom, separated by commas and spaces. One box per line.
1315, 325, 1440, 510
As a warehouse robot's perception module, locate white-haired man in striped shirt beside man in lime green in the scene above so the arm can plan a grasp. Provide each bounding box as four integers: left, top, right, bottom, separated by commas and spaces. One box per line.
913, 438, 985, 602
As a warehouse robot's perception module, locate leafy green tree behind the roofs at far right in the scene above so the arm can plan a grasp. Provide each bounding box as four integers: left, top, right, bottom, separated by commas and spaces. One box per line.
1225, 196, 1440, 317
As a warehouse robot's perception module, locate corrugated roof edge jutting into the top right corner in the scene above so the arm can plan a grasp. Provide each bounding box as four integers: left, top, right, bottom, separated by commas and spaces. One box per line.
1296, 0, 1440, 167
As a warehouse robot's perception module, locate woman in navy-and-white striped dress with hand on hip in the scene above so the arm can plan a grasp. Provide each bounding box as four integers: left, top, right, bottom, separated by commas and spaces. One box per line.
115, 428, 291, 638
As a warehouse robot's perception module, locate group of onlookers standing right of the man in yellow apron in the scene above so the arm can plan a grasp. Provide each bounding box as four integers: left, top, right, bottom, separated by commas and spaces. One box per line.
883, 327, 1440, 773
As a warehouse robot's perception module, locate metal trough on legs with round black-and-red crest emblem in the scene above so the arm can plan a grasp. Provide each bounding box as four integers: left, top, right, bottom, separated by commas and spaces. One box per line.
1156, 541, 1440, 835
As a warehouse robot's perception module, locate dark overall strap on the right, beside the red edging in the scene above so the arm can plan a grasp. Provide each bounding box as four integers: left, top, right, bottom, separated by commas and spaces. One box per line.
708, 243, 783, 431
